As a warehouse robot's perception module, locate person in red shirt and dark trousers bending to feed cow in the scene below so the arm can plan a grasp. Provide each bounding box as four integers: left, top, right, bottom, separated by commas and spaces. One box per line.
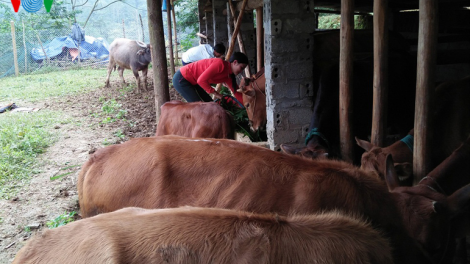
173, 52, 248, 105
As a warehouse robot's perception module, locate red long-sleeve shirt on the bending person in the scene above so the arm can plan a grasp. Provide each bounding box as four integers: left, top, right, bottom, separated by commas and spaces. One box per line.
180, 58, 243, 104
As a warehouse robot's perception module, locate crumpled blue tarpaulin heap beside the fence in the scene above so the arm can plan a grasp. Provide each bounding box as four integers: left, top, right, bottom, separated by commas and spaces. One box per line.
31, 36, 109, 62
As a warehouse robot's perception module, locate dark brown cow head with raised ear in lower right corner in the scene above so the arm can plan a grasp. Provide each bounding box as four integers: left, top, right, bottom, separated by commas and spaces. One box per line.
378, 154, 470, 263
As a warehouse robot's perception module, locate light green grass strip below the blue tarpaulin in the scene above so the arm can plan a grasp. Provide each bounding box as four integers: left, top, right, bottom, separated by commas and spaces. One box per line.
0, 68, 107, 102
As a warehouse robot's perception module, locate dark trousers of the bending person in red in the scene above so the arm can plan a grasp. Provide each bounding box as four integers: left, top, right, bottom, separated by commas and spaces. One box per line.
173, 70, 212, 103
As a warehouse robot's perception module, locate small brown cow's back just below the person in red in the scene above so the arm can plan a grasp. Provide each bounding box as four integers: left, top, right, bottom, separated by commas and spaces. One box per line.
155, 101, 235, 139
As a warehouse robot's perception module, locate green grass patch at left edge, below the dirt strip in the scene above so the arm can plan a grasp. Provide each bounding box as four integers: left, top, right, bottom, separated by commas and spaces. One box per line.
0, 110, 65, 198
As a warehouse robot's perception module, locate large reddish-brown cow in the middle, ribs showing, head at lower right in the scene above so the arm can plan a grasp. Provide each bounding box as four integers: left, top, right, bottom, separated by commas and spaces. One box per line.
77, 136, 470, 263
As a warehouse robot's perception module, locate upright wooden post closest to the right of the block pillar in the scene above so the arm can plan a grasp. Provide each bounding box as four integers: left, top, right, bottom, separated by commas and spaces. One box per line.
339, 0, 354, 162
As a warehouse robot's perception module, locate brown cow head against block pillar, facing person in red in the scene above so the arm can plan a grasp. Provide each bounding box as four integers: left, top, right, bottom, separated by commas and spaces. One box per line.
237, 74, 266, 131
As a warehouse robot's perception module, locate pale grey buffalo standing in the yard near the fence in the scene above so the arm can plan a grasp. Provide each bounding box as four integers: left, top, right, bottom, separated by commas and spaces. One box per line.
106, 38, 152, 93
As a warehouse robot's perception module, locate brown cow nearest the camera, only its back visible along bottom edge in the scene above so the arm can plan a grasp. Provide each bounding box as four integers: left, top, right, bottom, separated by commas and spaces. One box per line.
13, 207, 393, 264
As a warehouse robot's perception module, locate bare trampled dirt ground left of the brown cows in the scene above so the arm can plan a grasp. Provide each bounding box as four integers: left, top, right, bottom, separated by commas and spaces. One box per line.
0, 71, 182, 264
